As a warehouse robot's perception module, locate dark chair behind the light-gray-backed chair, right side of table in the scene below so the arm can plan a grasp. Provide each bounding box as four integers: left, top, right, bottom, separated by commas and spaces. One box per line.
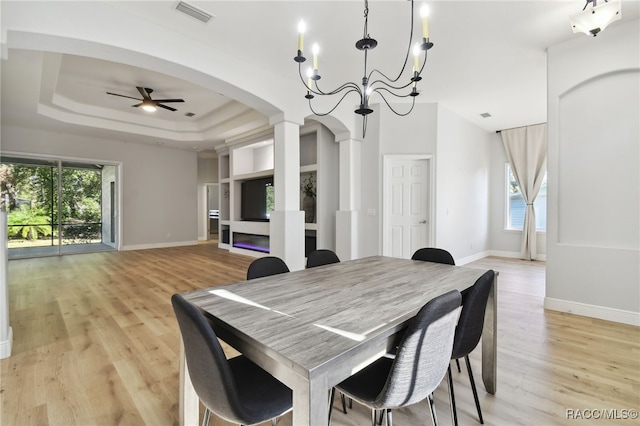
448, 270, 495, 425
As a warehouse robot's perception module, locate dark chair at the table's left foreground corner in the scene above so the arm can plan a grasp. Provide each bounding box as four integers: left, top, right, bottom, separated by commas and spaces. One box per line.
171, 294, 293, 426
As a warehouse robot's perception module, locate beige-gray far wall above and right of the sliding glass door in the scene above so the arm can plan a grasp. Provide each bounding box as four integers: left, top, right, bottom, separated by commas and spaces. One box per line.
2, 125, 197, 250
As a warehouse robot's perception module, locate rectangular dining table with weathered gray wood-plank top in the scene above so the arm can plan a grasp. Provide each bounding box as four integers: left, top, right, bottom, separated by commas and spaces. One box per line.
179, 256, 498, 426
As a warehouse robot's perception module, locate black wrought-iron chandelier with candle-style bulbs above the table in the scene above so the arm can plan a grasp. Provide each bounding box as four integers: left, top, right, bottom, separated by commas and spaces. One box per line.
293, 0, 433, 138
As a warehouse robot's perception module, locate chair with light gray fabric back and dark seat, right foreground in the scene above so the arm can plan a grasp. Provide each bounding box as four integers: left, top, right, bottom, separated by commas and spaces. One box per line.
336, 290, 462, 426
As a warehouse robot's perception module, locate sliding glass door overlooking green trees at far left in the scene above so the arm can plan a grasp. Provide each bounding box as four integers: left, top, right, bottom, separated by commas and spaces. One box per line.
0, 157, 117, 258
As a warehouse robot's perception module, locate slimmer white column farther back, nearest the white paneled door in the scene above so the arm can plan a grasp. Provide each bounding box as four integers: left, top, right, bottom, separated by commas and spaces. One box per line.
336, 139, 361, 260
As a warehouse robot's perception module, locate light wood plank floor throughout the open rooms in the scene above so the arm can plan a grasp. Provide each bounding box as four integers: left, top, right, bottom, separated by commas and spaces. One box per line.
0, 244, 640, 426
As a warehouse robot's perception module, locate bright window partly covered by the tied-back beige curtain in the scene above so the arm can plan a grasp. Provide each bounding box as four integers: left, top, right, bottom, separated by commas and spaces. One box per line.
505, 163, 547, 231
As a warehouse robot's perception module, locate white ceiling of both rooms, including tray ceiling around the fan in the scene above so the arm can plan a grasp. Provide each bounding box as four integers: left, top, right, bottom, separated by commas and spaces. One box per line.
1, 0, 640, 152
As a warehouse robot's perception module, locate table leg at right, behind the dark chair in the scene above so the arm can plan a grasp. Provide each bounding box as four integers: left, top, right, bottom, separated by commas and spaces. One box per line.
482, 273, 498, 395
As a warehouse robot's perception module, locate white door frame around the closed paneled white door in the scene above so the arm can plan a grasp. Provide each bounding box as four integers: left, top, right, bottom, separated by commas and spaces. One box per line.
380, 154, 435, 256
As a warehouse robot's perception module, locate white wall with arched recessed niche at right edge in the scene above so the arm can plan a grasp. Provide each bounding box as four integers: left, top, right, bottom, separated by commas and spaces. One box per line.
545, 21, 640, 325
